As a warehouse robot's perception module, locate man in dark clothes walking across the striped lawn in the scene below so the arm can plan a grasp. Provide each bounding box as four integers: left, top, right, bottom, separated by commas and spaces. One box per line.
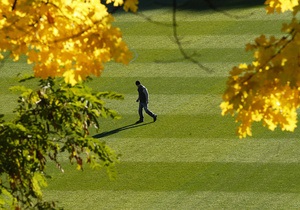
135, 81, 157, 123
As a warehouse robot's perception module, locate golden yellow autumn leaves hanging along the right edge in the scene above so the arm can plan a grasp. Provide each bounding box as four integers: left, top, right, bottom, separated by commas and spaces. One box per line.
221, 0, 300, 138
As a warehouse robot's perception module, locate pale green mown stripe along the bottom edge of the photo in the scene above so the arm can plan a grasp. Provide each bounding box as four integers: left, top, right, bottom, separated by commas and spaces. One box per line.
45, 190, 300, 210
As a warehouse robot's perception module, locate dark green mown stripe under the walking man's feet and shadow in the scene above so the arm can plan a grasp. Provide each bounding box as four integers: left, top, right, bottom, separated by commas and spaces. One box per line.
92, 113, 300, 141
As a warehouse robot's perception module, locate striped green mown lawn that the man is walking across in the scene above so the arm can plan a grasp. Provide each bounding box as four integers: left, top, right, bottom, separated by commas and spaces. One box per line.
0, 1, 300, 210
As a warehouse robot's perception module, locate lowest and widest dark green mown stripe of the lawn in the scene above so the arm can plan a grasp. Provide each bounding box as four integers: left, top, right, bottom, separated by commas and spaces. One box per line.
48, 162, 300, 193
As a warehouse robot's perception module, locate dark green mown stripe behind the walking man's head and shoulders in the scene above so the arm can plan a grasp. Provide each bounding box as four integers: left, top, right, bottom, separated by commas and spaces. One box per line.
90, 76, 227, 94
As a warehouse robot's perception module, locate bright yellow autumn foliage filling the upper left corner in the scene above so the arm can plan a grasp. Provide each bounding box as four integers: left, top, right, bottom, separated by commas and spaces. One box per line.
0, 0, 138, 85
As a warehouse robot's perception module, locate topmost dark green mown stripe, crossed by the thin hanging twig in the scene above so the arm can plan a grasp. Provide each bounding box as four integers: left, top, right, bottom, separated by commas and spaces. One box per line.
116, 18, 287, 37
